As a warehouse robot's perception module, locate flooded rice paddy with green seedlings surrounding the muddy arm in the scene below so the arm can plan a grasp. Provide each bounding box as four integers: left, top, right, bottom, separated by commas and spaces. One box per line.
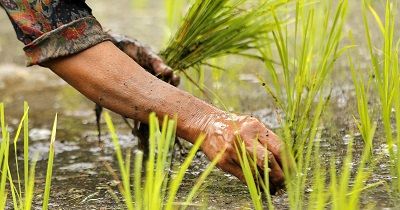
0, 0, 400, 209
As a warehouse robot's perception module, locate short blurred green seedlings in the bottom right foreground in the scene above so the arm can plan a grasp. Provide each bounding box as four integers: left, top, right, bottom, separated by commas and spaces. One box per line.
288, 130, 383, 210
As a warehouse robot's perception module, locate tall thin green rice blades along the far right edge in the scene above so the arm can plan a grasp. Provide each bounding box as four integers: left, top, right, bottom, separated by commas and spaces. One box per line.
362, 0, 400, 192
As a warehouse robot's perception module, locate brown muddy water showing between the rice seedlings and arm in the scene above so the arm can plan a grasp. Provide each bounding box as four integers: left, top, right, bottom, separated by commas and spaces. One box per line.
0, 0, 397, 209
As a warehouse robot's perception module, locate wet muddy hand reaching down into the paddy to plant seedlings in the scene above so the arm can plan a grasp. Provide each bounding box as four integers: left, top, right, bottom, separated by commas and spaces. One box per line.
202, 114, 284, 191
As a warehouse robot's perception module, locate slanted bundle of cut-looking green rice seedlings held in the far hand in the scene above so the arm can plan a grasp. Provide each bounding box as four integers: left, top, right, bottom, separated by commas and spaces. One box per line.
161, 0, 291, 71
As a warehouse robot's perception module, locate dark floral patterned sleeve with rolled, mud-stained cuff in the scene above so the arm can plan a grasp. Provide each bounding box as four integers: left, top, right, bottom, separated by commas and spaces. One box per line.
0, 0, 110, 66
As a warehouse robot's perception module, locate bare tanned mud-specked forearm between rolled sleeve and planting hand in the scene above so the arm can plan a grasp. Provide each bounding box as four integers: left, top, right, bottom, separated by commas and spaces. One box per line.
45, 42, 222, 142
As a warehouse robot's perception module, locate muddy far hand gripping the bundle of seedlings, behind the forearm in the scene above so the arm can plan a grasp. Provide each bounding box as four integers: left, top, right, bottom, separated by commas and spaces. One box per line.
111, 34, 180, 86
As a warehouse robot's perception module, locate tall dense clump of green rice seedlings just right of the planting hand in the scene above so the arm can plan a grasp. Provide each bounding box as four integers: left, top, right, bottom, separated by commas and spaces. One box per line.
260, 0, 348, 209
